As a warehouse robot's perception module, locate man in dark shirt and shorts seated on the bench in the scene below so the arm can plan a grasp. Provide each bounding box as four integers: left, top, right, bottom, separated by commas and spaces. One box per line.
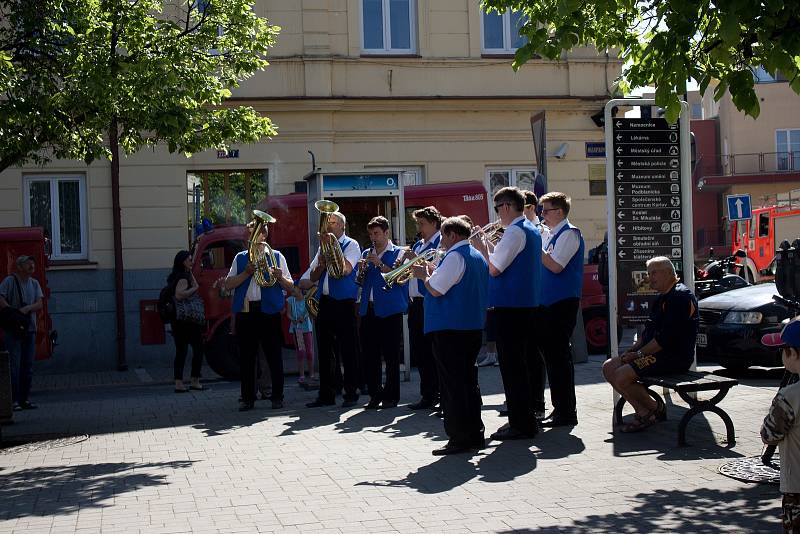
603, 256, 699, 432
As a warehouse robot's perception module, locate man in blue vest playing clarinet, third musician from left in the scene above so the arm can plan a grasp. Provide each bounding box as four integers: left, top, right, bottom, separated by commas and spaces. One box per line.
358, 216, 408, 409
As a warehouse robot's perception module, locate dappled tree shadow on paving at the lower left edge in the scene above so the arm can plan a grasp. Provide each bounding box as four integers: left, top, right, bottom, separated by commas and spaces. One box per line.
0, 460, 194, 520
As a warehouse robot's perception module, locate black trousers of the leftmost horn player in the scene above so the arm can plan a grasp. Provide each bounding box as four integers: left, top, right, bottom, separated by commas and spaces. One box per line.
236, 302, 283, 402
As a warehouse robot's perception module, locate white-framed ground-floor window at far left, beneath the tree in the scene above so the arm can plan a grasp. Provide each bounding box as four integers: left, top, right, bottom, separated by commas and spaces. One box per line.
24, 174, 89, 260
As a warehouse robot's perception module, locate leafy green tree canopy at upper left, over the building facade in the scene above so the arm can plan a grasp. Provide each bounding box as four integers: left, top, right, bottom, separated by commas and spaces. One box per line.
0, 0, 279, 170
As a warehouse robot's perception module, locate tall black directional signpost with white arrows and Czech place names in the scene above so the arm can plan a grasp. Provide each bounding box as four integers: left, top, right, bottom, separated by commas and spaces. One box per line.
606, 99, 694, 355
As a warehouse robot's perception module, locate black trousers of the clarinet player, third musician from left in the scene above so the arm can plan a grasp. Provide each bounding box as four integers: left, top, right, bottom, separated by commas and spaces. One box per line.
361, 305, 403, 404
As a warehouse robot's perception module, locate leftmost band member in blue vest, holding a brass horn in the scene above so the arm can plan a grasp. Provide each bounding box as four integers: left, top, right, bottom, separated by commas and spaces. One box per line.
225, 222, 294, 412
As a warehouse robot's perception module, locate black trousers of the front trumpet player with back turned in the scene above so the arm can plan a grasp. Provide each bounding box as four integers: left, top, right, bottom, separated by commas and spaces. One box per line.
431, 330, 484, 446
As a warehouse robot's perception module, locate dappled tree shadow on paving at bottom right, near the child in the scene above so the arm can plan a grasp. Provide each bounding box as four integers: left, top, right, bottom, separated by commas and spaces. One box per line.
502, 485, 780, 534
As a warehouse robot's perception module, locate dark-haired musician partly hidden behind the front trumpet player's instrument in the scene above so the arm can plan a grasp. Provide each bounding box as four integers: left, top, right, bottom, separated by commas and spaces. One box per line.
405, 206, 442, 410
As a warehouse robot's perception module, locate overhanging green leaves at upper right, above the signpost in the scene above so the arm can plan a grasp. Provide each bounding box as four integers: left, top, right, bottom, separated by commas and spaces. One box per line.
482, 0, 800, 120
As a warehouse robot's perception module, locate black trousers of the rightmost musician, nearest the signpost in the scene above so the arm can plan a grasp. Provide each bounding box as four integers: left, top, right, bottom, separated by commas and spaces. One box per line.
540, 298, 580, 419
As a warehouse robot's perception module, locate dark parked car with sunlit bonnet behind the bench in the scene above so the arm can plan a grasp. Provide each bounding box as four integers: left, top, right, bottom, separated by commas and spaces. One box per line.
697, 282, 794, 369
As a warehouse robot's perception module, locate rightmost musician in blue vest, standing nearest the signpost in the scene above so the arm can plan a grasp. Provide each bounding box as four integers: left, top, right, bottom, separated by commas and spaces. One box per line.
539, 192, 585, 427
